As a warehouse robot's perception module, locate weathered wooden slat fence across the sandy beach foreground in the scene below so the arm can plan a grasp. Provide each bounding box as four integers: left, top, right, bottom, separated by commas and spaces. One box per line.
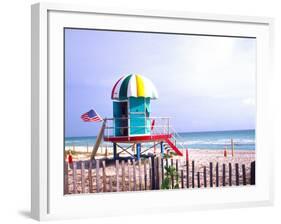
64, 157, 255, 194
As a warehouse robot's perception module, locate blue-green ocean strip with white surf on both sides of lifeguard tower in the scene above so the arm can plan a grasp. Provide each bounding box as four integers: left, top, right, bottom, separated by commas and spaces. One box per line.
65, 130, 255, 150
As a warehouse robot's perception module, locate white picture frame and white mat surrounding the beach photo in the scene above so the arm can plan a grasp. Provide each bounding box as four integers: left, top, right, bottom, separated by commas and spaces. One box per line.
31, 3, 274, 220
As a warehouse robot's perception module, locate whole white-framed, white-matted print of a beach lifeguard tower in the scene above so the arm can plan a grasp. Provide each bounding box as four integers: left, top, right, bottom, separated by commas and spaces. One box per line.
31, 3, 273, 220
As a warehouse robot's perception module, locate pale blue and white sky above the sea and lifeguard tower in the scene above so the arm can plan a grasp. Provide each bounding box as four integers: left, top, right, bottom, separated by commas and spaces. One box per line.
65, 29, 256, 137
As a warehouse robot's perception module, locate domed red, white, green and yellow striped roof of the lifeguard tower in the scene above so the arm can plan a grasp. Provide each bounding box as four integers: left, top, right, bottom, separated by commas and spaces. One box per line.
111, 74, 158, 100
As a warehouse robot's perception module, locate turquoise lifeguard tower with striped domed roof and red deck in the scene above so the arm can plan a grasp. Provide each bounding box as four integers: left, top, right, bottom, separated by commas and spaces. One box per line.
98, 74, 182, 159
